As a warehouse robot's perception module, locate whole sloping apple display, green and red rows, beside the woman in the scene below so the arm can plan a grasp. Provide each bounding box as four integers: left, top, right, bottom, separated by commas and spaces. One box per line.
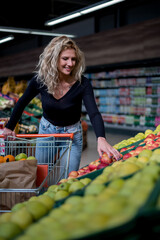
0, 126, 160, 240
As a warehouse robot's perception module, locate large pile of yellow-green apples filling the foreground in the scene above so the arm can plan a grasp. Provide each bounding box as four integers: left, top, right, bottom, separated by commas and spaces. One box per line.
0, 156, 160, 240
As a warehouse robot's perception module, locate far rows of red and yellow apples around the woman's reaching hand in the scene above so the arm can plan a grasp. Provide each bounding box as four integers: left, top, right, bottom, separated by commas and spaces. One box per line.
68, 125, 160, 178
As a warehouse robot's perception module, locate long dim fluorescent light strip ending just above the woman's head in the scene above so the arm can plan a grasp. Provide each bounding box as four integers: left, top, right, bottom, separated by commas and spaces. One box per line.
0, 26, 75, 37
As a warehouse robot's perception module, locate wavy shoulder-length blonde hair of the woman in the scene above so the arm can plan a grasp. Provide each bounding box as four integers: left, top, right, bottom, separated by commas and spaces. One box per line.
37, 36, 85, 94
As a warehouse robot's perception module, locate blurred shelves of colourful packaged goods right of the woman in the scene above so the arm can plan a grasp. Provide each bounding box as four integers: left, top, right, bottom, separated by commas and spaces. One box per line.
83, 62, 160, 131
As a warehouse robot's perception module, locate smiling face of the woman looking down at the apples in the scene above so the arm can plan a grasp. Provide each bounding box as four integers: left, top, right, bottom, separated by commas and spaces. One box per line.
58, 48, 76, 78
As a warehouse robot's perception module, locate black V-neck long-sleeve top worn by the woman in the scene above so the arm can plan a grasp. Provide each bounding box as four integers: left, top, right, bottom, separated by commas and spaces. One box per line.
6, 76, 105, 137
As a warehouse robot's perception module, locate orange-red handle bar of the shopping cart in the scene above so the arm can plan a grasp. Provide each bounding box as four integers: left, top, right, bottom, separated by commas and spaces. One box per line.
0, 133, 74, 140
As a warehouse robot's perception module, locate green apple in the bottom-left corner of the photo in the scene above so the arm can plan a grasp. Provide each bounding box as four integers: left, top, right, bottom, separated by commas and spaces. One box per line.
0, 222, 22, 239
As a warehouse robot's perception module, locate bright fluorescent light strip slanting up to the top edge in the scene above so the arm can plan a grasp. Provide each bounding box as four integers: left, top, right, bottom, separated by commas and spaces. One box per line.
45, 0, 125, 26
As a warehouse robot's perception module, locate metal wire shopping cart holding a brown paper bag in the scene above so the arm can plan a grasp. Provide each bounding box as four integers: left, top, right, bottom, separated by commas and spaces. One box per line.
0, 133, 74, 212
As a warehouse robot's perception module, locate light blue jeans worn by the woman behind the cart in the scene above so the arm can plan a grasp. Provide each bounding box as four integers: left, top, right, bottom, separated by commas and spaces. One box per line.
36, 117, 83, 172
